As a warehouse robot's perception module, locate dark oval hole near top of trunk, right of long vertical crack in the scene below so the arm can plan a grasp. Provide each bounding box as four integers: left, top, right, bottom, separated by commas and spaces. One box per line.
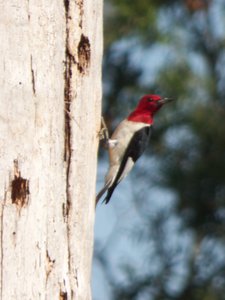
77, 34, 91, 75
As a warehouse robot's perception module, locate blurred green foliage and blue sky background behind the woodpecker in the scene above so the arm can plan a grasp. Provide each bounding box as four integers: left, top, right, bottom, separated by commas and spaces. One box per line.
93, 0, 225, 300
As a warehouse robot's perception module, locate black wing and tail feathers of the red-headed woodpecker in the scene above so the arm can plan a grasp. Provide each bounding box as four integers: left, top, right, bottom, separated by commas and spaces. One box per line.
103, 126, 152, 204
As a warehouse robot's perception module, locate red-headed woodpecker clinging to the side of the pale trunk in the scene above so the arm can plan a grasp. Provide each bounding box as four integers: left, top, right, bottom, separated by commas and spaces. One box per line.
96, 95, 173, 204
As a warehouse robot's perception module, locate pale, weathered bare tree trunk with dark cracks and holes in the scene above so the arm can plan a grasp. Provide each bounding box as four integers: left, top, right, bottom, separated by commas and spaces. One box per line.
0, 0, 102, 300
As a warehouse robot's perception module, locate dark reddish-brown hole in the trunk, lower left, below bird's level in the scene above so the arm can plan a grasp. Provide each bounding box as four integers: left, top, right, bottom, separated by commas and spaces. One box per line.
11, 160, 30, 209
